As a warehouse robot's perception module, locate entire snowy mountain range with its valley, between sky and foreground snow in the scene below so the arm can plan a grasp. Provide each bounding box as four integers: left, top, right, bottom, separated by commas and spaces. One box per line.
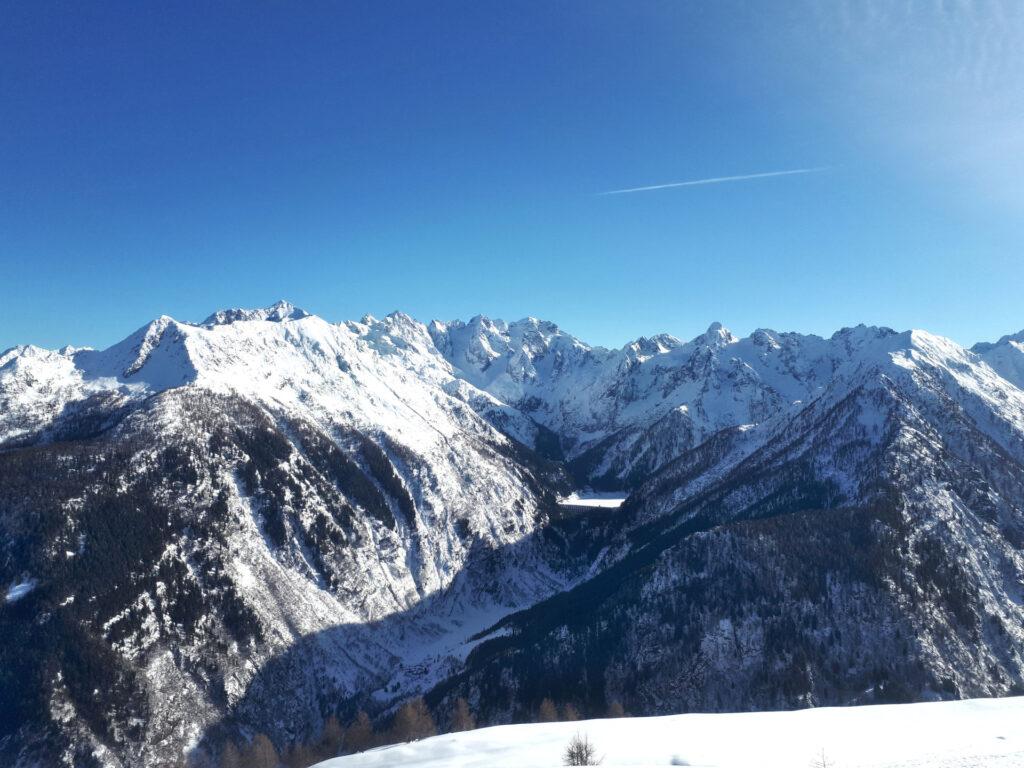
0, 302, 1024, 766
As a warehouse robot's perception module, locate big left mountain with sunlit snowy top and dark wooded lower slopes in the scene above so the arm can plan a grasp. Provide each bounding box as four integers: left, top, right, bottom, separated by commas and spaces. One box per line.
0, 305, 573, 765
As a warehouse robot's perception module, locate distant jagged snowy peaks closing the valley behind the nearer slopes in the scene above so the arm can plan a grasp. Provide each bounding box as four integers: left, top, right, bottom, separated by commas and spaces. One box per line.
429, 316, 1024, 488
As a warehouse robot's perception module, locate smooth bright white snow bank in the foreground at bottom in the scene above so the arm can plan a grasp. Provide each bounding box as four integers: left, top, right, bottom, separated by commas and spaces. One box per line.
319, 697, 1024, 768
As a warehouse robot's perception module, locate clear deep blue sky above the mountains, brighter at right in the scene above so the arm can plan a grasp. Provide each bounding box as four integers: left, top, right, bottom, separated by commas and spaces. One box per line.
0, 0, 1024, 349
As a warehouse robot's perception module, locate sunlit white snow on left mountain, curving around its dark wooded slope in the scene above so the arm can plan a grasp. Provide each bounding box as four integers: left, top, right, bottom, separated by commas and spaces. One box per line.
0, 303, 569, 663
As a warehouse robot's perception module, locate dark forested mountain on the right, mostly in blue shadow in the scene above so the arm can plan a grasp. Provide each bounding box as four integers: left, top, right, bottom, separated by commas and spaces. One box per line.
431, 329, 1024, 721
